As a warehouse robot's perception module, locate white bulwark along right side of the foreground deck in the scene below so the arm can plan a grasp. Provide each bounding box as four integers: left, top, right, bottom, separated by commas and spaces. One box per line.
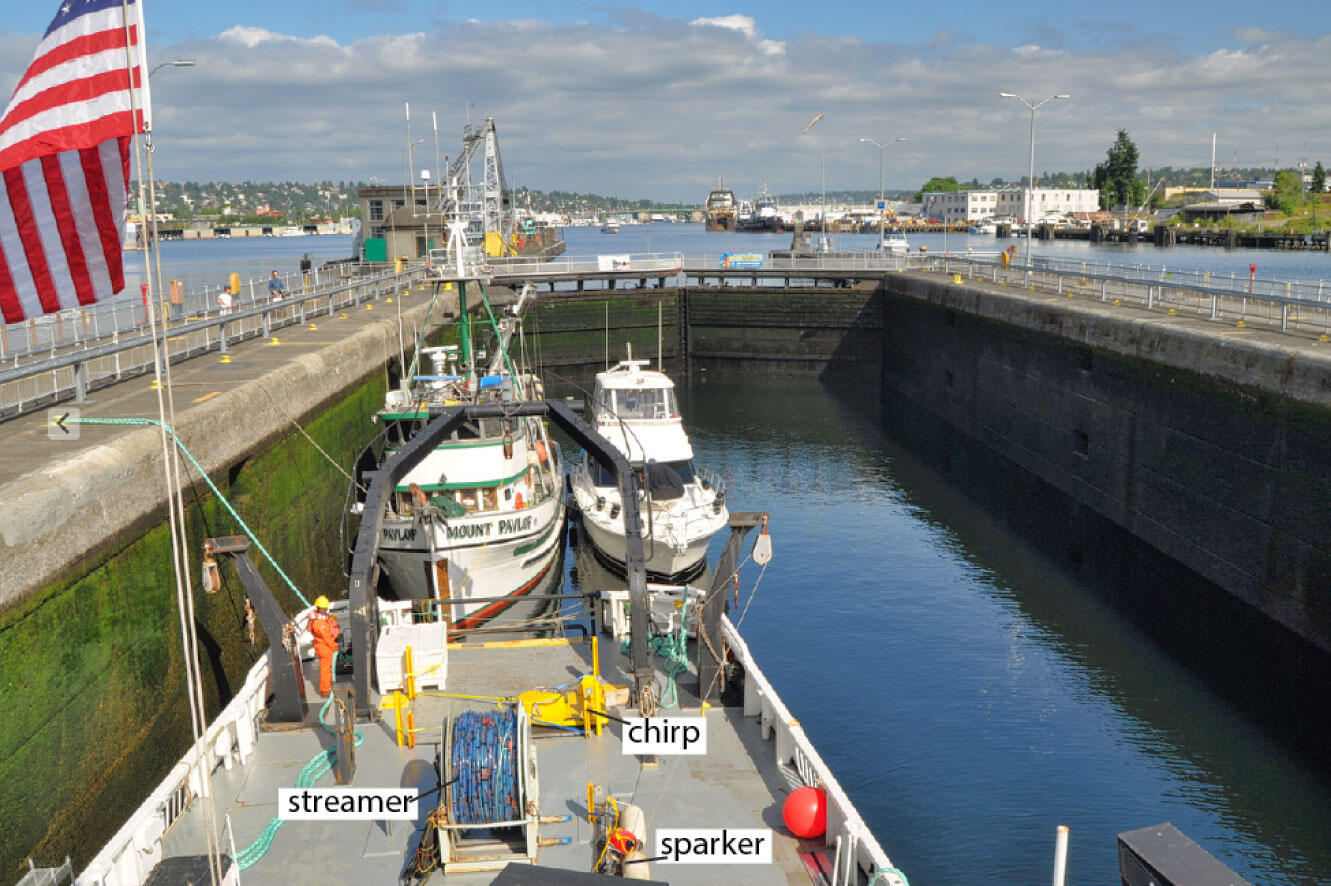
721, 616, 905, 886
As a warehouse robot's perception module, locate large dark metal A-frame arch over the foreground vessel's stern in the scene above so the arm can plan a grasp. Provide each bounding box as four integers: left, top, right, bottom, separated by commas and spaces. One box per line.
347, 400, 654, 718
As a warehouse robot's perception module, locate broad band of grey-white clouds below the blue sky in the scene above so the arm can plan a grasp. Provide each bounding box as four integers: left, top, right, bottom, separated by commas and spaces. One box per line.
41, 16, 1331, 200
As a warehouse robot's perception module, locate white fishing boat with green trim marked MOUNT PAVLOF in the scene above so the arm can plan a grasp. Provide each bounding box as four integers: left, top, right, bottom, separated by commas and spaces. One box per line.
359, 234, 564, 628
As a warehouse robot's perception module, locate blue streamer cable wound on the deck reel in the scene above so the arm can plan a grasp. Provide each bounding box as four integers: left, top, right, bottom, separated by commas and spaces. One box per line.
449, 708, 522, 825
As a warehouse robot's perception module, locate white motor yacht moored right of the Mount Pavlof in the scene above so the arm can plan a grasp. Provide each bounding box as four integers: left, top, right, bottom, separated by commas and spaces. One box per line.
570, 349, 728, 577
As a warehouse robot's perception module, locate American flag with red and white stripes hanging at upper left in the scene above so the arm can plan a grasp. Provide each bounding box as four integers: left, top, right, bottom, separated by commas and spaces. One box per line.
0, 0, 149, 323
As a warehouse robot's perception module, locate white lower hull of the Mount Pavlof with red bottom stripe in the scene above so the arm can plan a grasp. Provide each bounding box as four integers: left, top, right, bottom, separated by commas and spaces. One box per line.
379, 495, 564, 628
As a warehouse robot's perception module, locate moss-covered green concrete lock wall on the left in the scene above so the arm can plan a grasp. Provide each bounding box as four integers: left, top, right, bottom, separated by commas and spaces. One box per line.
0, 297, 425, 882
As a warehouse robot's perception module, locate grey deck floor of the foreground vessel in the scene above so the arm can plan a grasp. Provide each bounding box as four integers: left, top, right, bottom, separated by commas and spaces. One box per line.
164, 625, 812, 886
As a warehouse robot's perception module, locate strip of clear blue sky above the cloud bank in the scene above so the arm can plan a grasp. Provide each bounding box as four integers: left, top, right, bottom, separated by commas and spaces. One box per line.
4, 0, 1299, 51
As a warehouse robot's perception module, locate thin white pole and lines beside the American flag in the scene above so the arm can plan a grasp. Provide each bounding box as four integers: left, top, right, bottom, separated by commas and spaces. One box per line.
120, 0, 222, 886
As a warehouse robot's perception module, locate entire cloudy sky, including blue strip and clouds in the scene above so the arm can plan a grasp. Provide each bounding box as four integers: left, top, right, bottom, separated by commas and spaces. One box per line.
0, 0, 1331, 202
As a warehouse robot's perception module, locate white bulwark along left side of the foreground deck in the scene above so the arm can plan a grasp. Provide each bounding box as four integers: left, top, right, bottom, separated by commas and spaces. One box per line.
75, 655, 268, 886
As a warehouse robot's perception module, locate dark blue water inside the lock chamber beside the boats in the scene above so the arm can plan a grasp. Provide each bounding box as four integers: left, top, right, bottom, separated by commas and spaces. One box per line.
551, 372, 1331, 886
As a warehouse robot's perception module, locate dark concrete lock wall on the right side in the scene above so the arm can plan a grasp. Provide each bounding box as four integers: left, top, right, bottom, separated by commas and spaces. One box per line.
882, 275, 1331, 649
